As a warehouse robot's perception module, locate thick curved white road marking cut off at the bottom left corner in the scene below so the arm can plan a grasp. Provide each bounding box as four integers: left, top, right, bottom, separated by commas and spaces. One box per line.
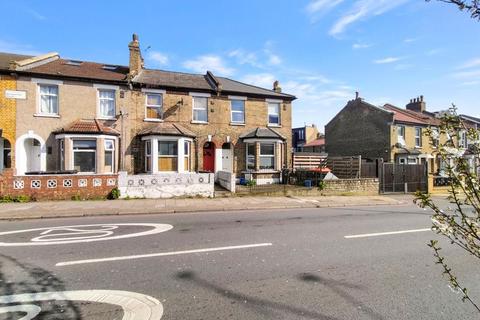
0, 290, 163, 320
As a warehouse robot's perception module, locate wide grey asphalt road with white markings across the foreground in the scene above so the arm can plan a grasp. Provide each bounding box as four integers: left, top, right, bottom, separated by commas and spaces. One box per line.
0, 201, 480, 320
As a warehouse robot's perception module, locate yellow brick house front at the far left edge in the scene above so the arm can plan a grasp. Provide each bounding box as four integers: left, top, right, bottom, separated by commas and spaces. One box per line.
0, 75, 17, 167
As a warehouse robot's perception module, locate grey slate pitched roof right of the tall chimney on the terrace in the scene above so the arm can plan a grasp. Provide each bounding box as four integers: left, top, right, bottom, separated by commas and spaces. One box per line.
133, 69, 296, 100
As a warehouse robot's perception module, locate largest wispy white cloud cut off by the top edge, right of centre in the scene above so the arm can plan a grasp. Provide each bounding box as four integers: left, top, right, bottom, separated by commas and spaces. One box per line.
329, 0, 409, 36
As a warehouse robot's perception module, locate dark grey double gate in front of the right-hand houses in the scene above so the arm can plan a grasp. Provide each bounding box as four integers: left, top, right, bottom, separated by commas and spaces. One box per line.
380, 163, 428, 193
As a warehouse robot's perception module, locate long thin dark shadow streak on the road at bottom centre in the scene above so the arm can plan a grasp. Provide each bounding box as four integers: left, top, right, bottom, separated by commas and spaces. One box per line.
176, 271, 338, 320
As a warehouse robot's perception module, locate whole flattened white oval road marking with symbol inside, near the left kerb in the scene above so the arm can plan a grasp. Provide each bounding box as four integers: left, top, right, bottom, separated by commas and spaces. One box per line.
0, 223, 173, 247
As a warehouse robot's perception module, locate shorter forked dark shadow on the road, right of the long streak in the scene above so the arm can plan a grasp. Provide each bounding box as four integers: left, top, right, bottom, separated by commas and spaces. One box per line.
297, 273, 385, 320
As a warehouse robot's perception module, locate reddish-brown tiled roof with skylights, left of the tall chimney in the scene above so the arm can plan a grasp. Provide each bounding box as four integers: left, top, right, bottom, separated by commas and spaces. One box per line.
26, 59, 129, 81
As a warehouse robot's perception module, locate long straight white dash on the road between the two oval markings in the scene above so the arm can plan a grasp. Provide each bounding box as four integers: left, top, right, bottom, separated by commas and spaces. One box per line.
55, 243, 273, 267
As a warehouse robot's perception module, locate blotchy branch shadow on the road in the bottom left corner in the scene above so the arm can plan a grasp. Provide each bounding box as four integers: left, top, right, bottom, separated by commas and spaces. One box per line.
0, 254, 82, 320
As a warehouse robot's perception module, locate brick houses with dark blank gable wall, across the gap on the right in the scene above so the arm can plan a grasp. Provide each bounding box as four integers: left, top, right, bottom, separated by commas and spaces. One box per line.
325, 96, 480, 175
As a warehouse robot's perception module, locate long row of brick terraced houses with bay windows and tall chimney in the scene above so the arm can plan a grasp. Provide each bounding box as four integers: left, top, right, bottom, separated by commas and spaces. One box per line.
0, 35, 295, 184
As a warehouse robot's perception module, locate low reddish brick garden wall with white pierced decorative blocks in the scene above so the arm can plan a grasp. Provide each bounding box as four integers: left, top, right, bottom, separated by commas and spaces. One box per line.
0, 170, 118, 200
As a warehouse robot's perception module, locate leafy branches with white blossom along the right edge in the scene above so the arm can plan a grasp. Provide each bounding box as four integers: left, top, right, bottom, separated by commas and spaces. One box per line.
416, 106, 480, 312
